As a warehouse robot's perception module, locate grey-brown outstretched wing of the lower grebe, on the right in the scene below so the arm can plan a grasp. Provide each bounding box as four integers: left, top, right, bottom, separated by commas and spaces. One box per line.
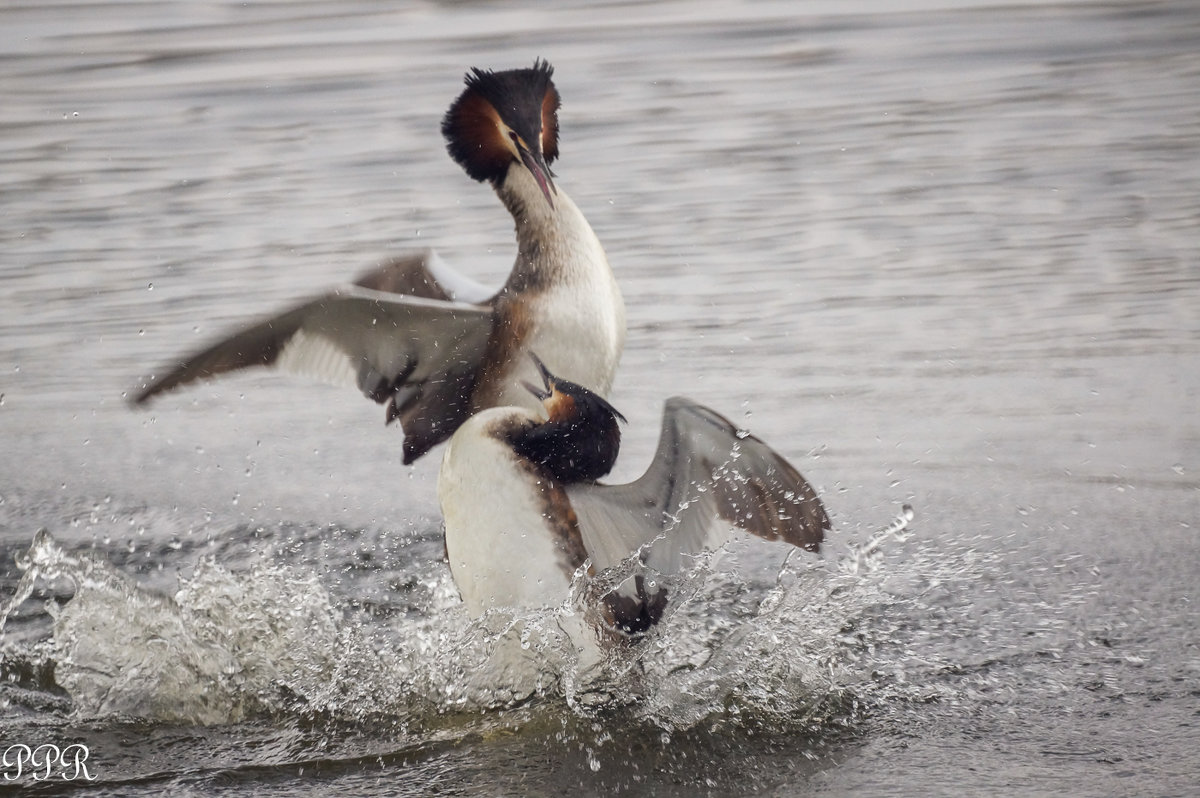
568, 397, 829, 574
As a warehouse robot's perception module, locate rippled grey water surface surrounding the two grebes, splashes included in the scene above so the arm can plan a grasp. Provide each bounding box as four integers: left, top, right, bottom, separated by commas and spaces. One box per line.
0, 0, 1200, 796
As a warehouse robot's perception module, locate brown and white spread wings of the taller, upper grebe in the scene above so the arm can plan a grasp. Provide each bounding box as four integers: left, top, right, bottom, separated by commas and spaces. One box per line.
131, 252, 493, 463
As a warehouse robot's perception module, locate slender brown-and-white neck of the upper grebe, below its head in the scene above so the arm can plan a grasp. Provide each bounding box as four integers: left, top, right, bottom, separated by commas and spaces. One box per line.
496, 163, 608, 290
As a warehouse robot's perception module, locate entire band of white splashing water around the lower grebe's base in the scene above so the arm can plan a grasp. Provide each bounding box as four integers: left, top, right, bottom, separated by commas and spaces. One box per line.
0, 508, 912, 730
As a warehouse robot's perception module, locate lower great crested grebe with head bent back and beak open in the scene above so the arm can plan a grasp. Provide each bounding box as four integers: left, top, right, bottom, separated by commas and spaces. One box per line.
438, 355, 829, 683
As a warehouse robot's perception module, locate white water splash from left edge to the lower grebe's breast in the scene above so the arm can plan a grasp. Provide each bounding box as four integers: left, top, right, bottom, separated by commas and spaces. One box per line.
0, 530, 628, 724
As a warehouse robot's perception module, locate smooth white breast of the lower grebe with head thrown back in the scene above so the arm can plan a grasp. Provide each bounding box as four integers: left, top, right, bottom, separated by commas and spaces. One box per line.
438, 407, 570, 617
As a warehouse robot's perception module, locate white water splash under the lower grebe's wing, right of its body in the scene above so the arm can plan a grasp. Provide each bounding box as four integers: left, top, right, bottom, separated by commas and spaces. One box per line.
552, 505, 914, 731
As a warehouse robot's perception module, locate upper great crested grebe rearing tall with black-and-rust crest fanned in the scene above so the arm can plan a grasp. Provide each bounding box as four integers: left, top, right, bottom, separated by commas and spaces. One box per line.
131, 60, 625, 463
